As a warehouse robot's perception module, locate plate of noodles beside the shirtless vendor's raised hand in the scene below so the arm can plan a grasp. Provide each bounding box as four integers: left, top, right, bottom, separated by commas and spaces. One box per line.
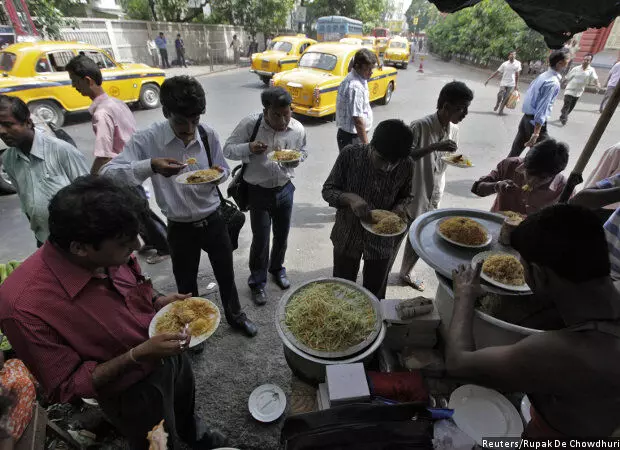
471, 251, 530, 292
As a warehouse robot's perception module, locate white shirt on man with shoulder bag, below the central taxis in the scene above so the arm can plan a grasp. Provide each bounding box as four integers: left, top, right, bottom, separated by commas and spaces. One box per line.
224, 113, 306, 188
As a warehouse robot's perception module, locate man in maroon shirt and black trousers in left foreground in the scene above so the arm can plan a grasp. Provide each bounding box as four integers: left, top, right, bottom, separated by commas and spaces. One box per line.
0, 176, 224, 448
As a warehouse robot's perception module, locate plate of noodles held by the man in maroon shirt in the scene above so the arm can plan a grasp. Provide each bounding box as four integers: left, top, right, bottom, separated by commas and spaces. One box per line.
149, 297, 221, 347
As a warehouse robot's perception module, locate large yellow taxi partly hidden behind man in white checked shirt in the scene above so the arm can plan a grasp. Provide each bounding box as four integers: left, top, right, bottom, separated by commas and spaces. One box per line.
271, 43, 397, 117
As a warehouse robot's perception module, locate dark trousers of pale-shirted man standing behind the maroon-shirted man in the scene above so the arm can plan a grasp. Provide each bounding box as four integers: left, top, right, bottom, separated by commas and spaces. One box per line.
168, 212, 243, 324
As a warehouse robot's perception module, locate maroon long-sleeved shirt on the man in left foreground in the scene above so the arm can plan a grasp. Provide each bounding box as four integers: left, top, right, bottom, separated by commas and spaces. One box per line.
0, 242, 155, 402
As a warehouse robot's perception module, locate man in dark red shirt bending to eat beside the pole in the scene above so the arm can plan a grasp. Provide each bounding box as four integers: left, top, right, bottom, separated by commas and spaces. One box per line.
471, 139, 568, 215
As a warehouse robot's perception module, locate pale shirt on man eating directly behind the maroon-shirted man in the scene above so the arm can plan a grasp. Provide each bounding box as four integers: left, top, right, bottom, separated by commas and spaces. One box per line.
100, 121, 230, 222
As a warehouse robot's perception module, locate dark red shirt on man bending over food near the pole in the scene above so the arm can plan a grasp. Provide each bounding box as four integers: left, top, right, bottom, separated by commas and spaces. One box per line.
471, 158, 566, 215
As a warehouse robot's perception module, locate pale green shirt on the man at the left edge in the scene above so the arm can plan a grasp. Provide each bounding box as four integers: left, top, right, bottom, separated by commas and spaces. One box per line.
2, 129, 89, 242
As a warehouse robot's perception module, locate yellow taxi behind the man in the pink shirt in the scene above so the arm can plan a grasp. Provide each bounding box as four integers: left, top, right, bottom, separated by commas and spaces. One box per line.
0, 41, 166, 127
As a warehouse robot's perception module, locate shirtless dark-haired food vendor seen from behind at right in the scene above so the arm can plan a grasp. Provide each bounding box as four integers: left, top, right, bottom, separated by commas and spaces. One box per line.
446, 204, 620, 438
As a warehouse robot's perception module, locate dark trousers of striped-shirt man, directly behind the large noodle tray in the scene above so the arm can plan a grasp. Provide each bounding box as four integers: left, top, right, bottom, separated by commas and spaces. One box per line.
333, 249, 392, 300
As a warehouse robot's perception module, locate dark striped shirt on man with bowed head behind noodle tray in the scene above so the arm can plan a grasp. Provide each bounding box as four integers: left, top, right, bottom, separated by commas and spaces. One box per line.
323, 144, 413, 260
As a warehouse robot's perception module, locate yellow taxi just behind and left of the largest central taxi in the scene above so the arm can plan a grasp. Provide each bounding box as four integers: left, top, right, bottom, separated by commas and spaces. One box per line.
250, 34, 316, 84
